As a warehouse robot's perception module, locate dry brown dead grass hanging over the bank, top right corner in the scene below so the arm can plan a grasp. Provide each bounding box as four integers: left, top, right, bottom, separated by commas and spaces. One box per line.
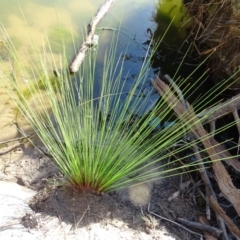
185, 0, 240, 88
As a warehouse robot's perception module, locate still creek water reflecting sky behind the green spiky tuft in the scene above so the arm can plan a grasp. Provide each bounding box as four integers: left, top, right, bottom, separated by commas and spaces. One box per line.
0, 0, 186, 141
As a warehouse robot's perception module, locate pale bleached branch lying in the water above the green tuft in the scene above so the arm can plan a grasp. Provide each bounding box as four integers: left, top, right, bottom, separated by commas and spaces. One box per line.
69, 0, 114, 73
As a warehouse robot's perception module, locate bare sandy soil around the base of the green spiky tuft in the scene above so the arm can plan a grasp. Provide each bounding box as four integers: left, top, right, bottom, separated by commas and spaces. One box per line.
0, 140, 202, 239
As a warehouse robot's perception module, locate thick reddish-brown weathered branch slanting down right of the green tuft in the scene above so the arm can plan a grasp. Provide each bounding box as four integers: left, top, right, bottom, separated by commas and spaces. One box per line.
152, 77, 240, 236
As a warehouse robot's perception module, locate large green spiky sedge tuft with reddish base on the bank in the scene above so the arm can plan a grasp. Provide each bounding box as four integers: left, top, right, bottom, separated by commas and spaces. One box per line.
1, 23, 239, 192
